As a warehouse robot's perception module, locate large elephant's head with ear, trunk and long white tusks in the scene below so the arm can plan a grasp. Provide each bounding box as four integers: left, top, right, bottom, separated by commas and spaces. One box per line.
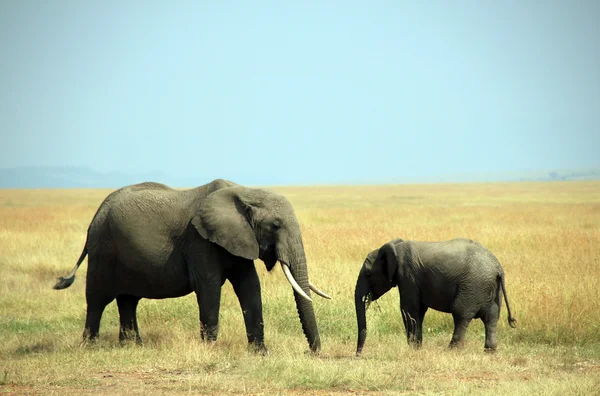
192, 186, 329, 352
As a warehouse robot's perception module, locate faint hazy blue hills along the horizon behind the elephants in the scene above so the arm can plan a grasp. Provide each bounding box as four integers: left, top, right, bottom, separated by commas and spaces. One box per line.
0, 167, 600, 188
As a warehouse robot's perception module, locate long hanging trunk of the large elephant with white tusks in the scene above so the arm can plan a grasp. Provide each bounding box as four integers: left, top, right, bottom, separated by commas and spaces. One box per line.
280, 242, 321, 352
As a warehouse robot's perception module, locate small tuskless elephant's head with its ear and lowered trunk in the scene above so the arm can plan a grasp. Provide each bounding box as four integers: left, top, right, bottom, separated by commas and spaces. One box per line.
354, 239, 402, 355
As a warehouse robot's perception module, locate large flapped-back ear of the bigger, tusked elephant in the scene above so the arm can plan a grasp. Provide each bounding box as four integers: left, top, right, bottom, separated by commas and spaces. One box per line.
192, 187, 258, 260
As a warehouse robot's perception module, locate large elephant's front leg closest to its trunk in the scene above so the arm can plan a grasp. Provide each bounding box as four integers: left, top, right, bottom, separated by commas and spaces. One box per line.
228, 262, 268, 353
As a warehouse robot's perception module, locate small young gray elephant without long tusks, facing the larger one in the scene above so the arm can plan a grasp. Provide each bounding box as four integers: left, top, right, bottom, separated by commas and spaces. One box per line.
354, 239, 516, 355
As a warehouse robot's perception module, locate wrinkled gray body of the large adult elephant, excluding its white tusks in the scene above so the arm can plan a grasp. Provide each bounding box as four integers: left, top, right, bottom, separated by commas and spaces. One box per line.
54, 179, 321, 352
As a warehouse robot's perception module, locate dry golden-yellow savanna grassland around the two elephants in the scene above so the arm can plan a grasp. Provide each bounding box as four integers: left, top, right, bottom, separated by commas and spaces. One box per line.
0, 182, 600, 395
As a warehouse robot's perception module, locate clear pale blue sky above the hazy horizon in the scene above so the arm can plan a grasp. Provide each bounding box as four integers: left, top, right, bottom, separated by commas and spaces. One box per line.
0, 0, 600, 184
